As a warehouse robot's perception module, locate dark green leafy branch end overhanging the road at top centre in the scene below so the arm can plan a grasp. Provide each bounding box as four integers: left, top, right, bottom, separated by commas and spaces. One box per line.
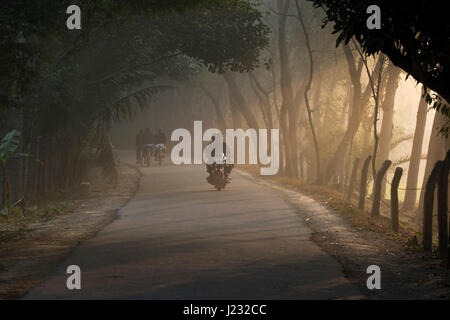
153, 1, 269, 73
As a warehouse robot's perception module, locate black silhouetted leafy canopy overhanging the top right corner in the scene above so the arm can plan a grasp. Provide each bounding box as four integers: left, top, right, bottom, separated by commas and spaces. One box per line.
308, 0, 450, 109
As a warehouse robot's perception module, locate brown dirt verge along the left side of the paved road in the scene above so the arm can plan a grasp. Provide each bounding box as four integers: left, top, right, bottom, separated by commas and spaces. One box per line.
0, 162, 142, 300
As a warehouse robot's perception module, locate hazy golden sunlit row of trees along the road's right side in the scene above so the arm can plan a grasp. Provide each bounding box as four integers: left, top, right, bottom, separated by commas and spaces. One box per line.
124, 0, 449, 222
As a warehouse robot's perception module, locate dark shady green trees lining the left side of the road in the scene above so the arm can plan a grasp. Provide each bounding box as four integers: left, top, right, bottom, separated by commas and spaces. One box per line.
0, 0, 268, 206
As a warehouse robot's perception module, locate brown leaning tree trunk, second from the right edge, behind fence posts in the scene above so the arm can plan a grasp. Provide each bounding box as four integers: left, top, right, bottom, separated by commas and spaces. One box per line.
402, 88, 428, 210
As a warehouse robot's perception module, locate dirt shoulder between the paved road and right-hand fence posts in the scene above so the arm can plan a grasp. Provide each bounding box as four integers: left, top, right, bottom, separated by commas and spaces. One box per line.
238, 170, 450, 300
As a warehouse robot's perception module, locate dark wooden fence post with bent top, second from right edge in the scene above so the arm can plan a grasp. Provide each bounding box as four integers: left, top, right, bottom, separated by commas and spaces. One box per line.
423, 161, 444, 252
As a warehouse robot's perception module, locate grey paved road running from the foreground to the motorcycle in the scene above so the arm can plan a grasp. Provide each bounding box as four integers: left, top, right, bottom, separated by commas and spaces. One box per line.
25, 155, 360, 299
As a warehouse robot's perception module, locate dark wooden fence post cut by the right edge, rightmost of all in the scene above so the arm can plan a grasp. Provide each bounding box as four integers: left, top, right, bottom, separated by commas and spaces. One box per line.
438, 150, 450, 259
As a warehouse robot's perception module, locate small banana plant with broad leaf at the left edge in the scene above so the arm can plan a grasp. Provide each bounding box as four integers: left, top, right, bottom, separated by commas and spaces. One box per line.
0, 129, 34, 215
